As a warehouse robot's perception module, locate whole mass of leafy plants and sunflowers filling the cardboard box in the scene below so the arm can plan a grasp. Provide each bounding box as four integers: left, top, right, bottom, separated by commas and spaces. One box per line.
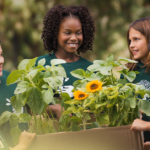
0, 55, 150, 143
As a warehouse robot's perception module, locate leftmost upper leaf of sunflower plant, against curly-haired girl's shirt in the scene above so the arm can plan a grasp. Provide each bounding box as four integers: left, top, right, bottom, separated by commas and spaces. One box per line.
70, 69, 86, 79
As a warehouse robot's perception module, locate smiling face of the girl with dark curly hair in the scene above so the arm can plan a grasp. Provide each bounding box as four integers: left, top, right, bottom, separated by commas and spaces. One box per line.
57, 17, 83, 54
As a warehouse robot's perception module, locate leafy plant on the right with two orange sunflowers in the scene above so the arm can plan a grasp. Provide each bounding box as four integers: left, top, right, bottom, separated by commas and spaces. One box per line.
63, 55, 150, 130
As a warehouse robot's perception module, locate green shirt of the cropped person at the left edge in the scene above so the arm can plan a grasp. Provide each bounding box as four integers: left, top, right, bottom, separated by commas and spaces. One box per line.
0, 70, 28, 146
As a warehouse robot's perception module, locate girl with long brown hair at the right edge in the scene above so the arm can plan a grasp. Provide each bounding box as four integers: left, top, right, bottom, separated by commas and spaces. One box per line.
127, 17, 150, 142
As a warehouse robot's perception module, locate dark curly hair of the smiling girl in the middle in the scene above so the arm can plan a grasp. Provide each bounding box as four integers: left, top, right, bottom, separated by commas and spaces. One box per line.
42, 5, 95, 54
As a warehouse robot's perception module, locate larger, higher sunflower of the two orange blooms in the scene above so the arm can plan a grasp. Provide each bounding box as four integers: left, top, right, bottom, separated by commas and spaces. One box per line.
86, 80, 103, 92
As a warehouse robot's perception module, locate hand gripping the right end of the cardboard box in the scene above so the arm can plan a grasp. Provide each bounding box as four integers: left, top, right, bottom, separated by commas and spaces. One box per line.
130, 119, 150, 131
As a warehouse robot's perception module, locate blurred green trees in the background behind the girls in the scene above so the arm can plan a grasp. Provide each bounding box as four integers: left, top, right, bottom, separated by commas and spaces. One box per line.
0, 0, 150, 71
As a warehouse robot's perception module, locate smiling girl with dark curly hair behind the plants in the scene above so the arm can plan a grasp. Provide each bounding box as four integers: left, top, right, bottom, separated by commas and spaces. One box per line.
37, 5, 95, 119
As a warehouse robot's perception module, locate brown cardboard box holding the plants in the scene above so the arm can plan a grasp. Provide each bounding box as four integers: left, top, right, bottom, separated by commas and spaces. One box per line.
28, 126, 143, 150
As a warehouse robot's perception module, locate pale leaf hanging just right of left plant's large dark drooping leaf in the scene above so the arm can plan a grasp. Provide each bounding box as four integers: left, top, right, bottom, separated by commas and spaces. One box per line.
42, 87, 53, 104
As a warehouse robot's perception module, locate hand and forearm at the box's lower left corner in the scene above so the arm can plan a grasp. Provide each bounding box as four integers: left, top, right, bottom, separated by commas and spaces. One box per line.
10, 131, 36, 150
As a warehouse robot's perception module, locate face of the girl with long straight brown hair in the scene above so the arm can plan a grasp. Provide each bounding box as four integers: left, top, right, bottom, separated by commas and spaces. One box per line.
129, 28, 149, 63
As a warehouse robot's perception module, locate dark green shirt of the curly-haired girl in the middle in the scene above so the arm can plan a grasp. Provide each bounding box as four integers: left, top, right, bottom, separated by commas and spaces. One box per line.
36, 53, 92, 97
